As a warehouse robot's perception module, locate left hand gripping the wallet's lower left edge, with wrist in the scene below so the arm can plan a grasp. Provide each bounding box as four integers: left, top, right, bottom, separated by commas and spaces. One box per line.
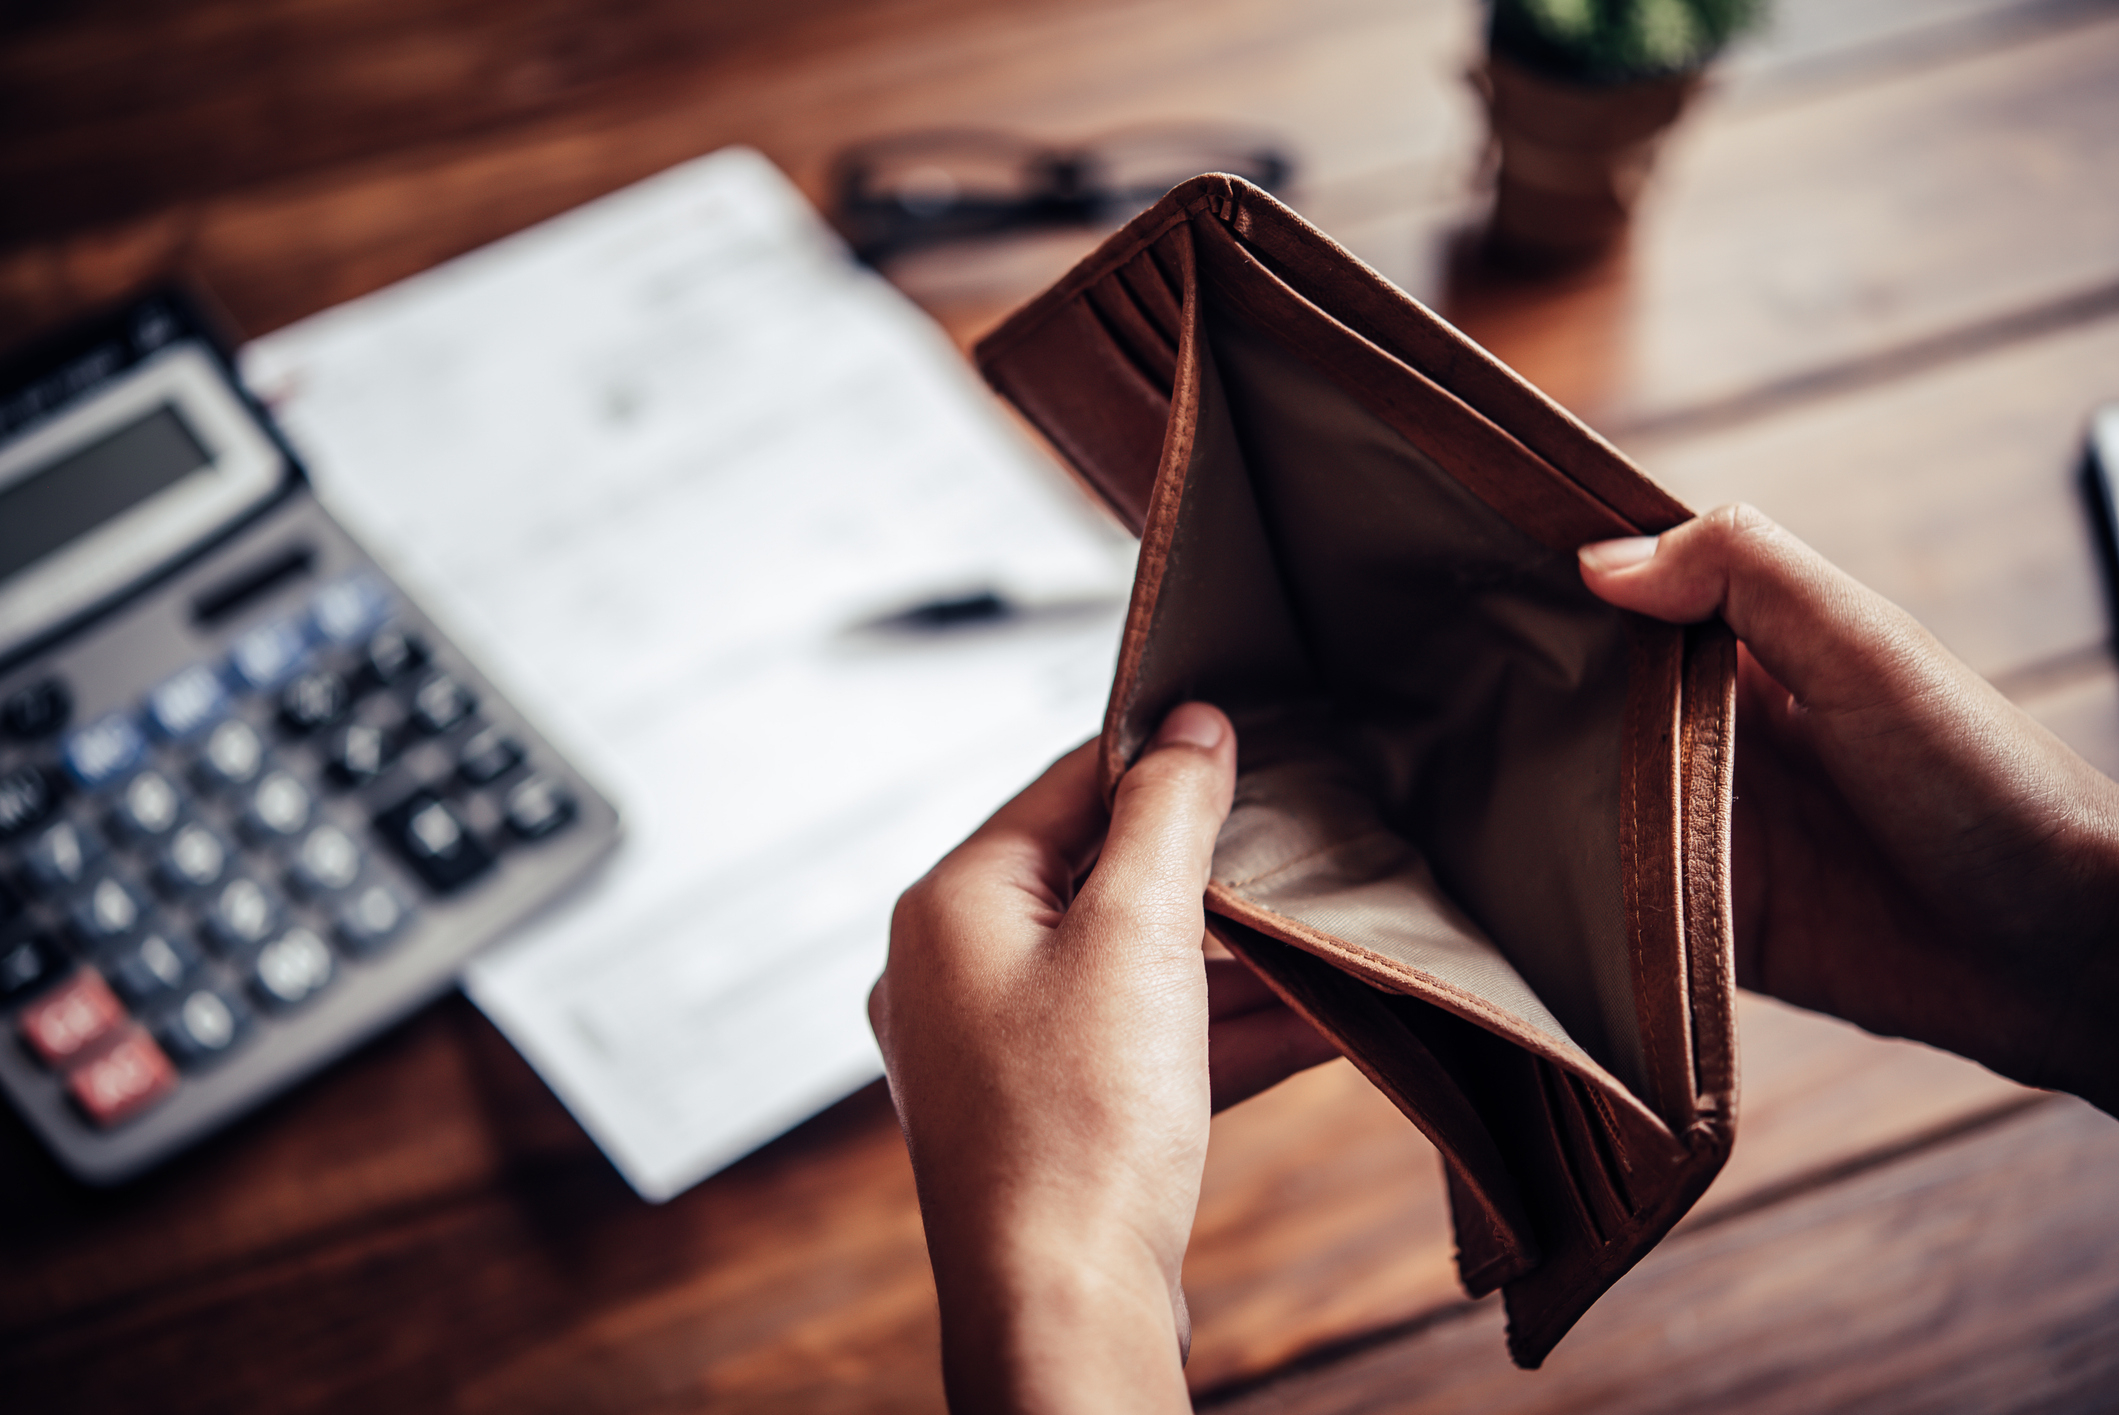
869, 703, 1337, 1411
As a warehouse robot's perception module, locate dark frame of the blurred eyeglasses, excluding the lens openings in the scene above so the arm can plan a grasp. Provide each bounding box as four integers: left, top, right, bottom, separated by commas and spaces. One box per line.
831, 125, 1295, 265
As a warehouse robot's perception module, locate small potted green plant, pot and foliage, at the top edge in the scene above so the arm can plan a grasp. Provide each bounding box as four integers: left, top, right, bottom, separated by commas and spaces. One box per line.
1477, 0, 1763, 267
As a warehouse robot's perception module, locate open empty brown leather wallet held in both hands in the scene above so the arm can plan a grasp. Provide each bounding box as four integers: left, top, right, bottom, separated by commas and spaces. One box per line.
977, 176, 1735, 1366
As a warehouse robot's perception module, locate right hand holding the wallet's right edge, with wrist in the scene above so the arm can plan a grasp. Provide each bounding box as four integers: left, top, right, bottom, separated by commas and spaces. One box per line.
1581, 506, 2119, 1114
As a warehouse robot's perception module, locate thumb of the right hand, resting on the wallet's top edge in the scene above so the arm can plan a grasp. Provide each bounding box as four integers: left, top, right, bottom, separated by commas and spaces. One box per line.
1579, 504, 1941, 712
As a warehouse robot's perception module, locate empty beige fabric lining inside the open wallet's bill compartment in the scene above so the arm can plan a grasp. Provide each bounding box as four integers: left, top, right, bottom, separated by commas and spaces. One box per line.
1123, 271, 1649, 1099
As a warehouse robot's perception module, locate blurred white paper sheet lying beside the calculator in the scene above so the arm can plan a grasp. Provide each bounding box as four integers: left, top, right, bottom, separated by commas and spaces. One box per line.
244, 148, 1132, 1199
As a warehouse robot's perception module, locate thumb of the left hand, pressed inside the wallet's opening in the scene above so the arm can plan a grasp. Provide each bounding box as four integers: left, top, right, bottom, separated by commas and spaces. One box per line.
1076, 703, 1235, 951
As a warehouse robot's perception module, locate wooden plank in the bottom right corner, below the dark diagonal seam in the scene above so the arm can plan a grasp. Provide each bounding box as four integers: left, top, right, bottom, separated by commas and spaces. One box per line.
1201, 1099, 2119, 1415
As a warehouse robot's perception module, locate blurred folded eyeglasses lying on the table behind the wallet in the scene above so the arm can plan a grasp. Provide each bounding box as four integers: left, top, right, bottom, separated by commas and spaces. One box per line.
833, 127, 1295, 265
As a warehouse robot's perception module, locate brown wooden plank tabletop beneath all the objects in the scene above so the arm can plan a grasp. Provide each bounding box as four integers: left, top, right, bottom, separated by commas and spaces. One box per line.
0, 0, 2119, 1415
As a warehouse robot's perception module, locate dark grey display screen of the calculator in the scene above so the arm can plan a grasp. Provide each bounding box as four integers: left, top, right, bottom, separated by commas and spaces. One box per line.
0, 402, 212, 580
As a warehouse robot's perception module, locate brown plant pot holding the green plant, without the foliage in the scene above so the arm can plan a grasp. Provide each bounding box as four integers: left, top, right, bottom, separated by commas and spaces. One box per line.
1473, 55, 1699, 267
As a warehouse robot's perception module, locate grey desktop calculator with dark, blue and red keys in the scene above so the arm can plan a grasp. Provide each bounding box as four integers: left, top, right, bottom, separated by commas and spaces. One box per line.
0, 290, 619, 1184
